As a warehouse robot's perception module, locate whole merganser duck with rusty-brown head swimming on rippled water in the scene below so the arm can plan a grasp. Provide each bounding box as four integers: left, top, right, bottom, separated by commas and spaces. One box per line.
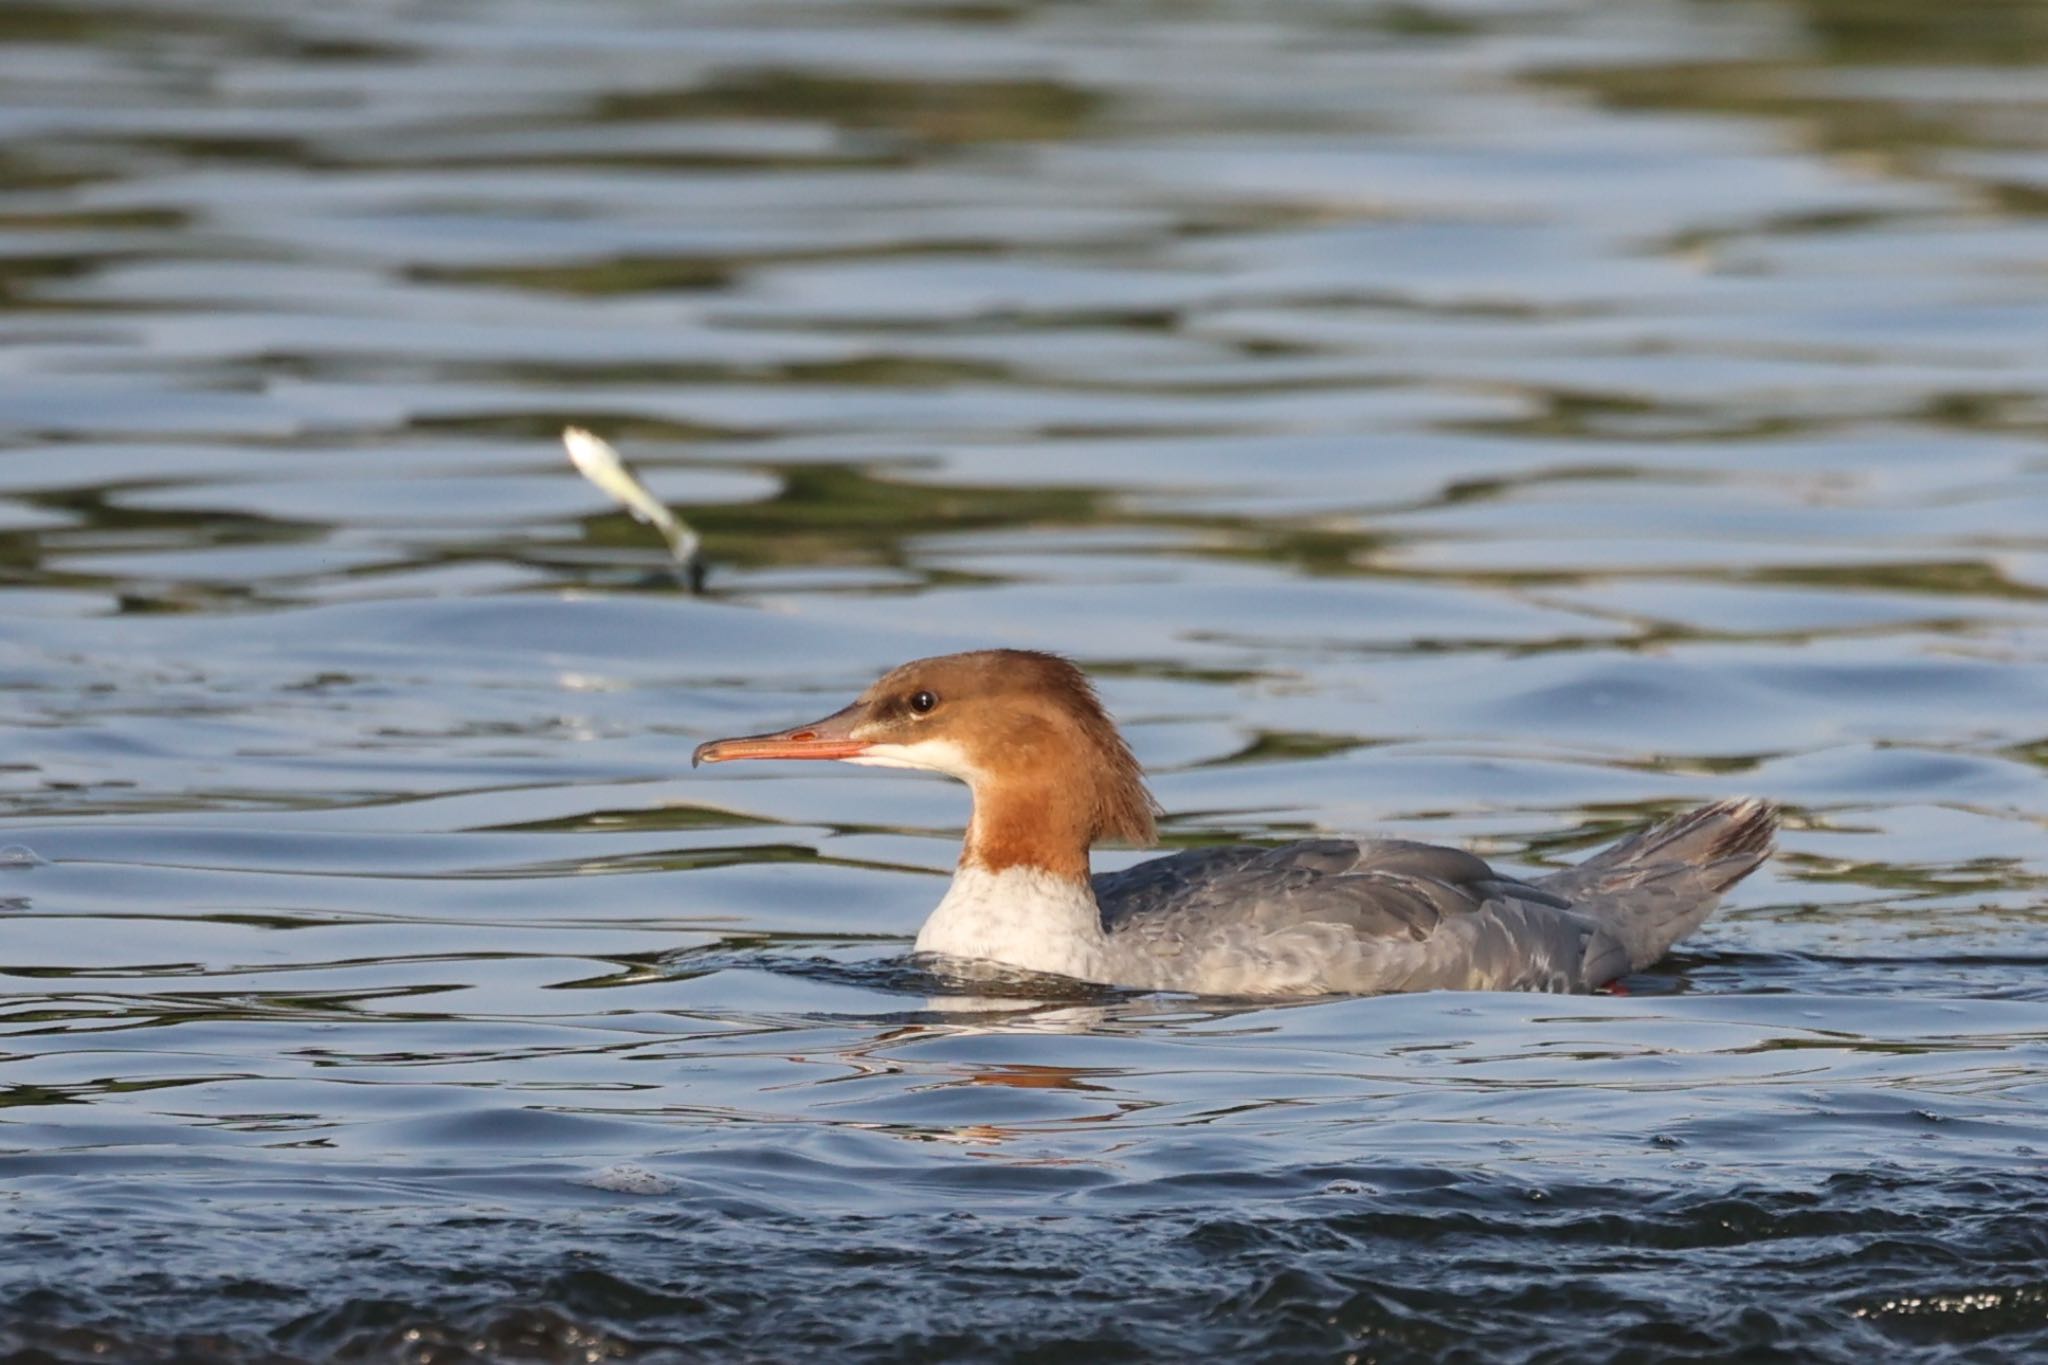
690, 649, 1778, 997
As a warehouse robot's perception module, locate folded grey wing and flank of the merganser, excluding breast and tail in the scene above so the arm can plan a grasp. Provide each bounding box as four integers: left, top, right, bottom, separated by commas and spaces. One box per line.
1094, 839, 1608, 995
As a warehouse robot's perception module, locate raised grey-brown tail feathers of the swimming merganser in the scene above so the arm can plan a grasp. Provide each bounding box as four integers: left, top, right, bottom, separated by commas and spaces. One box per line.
1538, 798, 1778, 984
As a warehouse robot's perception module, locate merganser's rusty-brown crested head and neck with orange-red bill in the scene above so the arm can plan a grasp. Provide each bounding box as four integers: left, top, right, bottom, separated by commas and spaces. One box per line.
690, 649, 1157, 878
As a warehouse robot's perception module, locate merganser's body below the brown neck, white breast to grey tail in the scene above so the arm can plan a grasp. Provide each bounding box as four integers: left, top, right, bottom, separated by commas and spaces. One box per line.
918, 802, 1772, 995
